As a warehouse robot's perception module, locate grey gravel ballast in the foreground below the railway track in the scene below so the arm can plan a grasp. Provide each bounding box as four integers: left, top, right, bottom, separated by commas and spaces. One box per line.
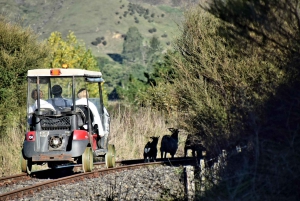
19, 166, 184, 201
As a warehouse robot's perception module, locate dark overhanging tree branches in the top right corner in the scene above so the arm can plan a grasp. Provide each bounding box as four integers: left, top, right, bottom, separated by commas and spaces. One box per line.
204, 0, 300, 77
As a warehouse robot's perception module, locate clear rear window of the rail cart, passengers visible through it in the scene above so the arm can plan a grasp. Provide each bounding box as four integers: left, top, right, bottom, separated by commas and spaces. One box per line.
27, 76, 101, 126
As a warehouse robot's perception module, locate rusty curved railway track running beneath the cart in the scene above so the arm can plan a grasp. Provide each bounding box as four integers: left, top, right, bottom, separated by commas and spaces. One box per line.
0, 158, 196, 201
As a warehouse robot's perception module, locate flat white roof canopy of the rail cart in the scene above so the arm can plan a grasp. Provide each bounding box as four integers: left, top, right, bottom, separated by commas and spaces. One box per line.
27, 68, 102, 78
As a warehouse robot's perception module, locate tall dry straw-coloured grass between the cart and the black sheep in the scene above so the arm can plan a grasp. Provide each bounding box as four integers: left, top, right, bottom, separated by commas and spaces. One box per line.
109, 103, 186, 160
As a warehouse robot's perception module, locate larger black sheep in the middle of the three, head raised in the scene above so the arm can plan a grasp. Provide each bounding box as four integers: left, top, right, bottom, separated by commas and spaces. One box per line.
160, 128, 179, 158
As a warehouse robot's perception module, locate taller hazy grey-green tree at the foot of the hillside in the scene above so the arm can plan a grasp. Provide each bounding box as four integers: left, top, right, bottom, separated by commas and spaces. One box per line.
122, 27, 143, 62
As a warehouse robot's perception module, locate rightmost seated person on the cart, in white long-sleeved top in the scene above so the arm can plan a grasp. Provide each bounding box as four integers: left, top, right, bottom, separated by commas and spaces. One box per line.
75, 88, 105, 137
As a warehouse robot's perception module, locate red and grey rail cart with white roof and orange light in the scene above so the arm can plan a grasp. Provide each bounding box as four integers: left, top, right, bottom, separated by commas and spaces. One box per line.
21, 68, 115, 174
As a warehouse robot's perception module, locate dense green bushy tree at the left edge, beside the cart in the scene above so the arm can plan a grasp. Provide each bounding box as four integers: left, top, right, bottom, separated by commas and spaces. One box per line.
0, 16, 48, 137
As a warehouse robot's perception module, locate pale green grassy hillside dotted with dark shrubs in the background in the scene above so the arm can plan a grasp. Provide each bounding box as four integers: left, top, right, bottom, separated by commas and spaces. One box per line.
0, 0, 190, 56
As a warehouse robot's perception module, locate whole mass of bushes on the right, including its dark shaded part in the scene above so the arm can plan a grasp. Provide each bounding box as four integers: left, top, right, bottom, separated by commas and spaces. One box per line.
156, 0, 300, 200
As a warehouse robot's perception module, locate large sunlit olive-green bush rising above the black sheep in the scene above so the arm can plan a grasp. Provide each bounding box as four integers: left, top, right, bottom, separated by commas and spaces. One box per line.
172, 9, 284, 147
